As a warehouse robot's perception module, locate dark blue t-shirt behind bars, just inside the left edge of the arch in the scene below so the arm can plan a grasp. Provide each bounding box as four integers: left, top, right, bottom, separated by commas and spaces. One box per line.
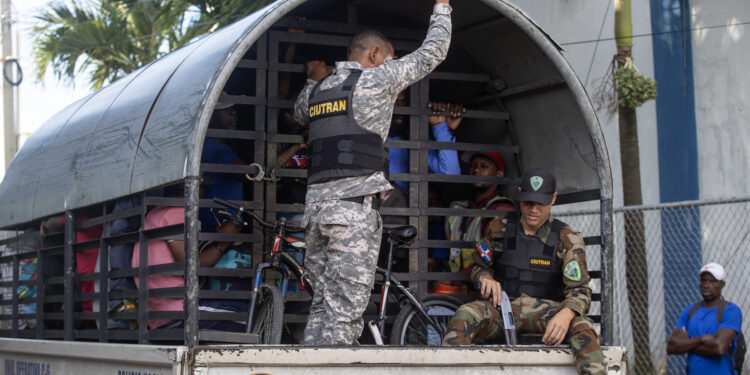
198, 137, 242, 231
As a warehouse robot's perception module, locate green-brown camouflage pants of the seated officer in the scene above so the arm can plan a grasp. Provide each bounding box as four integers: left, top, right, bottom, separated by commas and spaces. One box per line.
443, 294, 606, 374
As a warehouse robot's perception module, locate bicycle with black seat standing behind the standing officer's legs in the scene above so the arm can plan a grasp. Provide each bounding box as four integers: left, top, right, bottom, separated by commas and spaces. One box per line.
209, 198, 462, 345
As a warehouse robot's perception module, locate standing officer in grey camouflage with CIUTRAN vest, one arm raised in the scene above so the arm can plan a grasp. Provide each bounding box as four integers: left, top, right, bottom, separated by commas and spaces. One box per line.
294, 0, 452, 345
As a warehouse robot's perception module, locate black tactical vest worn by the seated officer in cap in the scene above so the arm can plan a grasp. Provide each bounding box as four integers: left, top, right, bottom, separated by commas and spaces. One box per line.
494, 214, 565, 301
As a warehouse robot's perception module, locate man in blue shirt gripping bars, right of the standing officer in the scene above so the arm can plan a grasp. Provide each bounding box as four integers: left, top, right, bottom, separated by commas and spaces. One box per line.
388, 92, 466, 195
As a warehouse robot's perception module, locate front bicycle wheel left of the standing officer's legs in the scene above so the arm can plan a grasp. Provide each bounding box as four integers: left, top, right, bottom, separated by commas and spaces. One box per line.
252, 284, 284, 345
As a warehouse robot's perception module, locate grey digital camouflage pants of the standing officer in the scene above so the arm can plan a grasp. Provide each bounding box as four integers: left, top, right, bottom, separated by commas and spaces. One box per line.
303, 198, 383, 345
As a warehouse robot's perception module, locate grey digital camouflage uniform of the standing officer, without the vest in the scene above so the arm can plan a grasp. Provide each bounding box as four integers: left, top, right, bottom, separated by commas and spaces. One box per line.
295, 4, 452, 345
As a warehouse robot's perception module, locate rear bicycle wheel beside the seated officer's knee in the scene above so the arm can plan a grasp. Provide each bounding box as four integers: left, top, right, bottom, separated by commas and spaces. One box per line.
391, 295, 461, 346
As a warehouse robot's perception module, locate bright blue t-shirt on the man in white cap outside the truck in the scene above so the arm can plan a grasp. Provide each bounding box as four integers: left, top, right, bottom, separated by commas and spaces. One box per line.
675, 302, 742, 375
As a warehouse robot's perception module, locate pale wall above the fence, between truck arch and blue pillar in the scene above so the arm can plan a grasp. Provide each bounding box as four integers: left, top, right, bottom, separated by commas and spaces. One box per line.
516, 0, 659, 208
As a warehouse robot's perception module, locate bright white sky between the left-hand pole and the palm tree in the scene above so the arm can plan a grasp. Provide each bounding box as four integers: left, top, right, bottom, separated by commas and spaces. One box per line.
11, 0, 92, 146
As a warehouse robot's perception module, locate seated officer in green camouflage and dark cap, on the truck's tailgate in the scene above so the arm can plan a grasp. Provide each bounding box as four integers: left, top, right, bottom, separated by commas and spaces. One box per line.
443, 169, 606, 374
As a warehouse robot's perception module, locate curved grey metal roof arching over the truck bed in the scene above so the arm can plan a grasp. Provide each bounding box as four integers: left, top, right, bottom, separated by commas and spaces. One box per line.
0, 0, 611, 227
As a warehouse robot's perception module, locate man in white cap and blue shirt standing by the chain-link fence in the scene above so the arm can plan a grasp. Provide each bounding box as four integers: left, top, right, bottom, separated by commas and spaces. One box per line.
667, 263, 742, 375
